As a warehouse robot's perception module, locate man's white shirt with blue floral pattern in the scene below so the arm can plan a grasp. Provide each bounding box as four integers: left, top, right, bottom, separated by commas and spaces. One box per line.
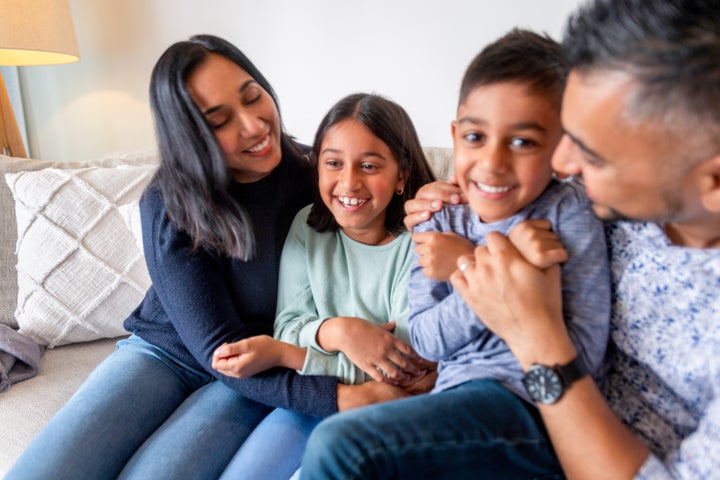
608, 222, 720, 480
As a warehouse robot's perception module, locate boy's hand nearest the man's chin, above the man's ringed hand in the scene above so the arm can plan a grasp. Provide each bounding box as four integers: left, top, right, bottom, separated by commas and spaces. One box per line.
508, 219, 567, 270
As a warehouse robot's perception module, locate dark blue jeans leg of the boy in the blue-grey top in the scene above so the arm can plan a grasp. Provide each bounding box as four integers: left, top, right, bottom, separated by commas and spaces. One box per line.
300, 380, 564, 480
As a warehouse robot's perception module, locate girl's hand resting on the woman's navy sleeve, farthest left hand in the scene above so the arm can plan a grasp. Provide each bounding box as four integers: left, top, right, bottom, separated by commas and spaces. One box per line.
212, 335, 305, 378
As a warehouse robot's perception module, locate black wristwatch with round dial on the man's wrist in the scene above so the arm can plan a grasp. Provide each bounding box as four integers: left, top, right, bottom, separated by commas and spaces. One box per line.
523, 357, 589, 405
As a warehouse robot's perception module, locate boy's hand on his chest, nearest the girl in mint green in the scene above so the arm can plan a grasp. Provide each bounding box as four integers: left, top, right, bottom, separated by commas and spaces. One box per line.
412, 232, 475, 282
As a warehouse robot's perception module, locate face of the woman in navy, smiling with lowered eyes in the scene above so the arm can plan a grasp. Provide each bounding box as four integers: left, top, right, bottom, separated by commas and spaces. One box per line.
186, 54, 281, 183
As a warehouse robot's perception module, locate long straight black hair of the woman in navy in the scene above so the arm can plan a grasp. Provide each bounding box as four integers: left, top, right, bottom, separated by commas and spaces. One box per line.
150, 35, 302, 260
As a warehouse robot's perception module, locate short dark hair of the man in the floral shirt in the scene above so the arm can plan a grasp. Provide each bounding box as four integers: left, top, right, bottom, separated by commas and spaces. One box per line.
562, 0, 720, 149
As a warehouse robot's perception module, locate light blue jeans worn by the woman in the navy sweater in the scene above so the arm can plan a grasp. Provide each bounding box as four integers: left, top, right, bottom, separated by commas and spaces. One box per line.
6, 336, 271, 480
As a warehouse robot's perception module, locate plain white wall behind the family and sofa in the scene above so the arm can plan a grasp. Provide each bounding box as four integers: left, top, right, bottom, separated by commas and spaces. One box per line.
19, 0, 578, 160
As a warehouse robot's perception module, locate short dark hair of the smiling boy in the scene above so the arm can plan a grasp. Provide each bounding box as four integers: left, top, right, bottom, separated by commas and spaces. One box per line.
458, 28, 568, 111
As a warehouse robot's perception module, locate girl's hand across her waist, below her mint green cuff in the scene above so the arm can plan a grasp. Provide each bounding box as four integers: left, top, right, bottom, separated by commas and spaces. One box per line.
317, 317, 424, 385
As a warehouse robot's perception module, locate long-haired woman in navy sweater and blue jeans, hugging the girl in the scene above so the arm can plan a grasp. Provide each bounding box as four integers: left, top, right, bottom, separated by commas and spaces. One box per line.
7, 35, 414, 479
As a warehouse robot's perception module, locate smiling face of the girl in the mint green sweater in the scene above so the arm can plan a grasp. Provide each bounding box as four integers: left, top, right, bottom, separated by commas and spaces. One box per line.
318, 120, 405, 245
